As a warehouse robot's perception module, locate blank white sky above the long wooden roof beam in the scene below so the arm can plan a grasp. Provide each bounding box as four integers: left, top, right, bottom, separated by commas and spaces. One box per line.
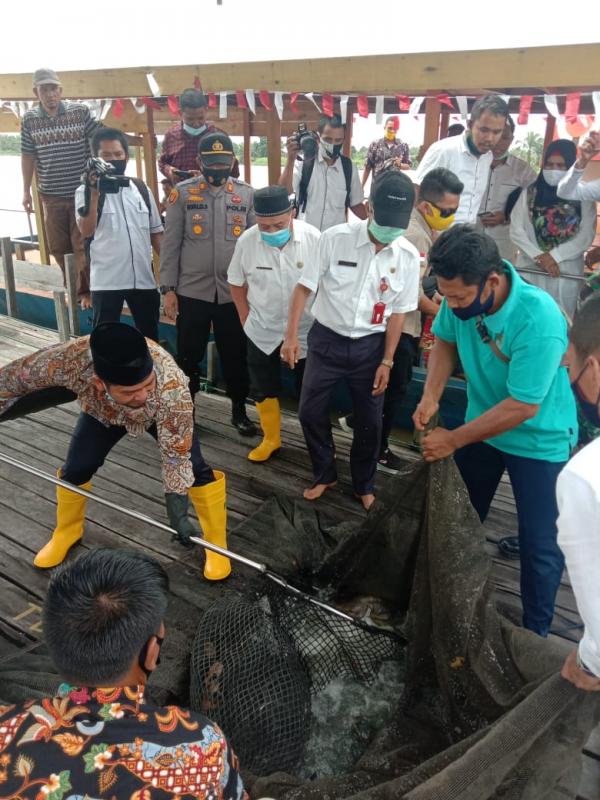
0, 0, 600, 72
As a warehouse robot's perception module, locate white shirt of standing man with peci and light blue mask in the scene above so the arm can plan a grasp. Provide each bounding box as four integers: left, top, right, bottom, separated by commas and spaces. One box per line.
227, 220, 321, 358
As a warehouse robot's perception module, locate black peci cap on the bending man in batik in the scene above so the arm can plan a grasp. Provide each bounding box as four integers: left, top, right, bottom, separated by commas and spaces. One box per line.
90, 322, 154, 386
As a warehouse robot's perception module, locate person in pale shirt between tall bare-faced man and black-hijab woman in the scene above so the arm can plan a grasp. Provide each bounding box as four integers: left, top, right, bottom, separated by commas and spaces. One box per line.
477, 116, 537, 264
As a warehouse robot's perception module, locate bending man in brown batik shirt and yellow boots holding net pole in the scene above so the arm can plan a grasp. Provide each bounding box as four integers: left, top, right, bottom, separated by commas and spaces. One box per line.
0, 322, 231, 580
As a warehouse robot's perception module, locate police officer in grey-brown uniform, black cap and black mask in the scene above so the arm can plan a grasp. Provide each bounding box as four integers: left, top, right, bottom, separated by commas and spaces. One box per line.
160, 133, 257, 436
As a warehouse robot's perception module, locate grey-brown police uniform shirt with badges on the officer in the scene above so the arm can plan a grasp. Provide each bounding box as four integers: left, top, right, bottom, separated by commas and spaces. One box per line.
160, 175, 256, 303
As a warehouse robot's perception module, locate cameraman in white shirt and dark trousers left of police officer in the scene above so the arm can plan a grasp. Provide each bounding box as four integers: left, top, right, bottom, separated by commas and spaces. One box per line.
75, 128, 163, 341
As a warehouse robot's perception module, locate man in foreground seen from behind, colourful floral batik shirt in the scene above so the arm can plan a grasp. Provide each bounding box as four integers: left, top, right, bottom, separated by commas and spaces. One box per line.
0, 548, 247, 800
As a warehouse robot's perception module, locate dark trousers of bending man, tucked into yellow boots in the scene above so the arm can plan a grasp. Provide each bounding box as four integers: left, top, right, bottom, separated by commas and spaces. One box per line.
61, 412, 214, 486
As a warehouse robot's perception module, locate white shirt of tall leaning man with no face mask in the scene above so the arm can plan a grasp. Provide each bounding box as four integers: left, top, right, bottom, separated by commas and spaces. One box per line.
415, 132, 494, 224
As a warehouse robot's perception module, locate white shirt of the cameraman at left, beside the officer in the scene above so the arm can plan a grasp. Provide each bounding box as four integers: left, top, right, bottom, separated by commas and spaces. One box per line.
75, 181, 163, 292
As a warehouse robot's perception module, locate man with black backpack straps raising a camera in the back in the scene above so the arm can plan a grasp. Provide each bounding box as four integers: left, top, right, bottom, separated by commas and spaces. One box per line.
279, 114, 367, 231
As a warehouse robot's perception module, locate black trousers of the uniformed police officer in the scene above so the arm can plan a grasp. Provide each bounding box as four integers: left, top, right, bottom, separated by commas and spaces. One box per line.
177, 295, 249, 402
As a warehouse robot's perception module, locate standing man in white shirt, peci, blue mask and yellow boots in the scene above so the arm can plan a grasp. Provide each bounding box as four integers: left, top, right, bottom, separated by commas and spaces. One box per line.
227, 186, 321, 461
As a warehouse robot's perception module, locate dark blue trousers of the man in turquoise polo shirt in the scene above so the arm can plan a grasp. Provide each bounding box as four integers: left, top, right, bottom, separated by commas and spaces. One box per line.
454, 442, 564, 636
